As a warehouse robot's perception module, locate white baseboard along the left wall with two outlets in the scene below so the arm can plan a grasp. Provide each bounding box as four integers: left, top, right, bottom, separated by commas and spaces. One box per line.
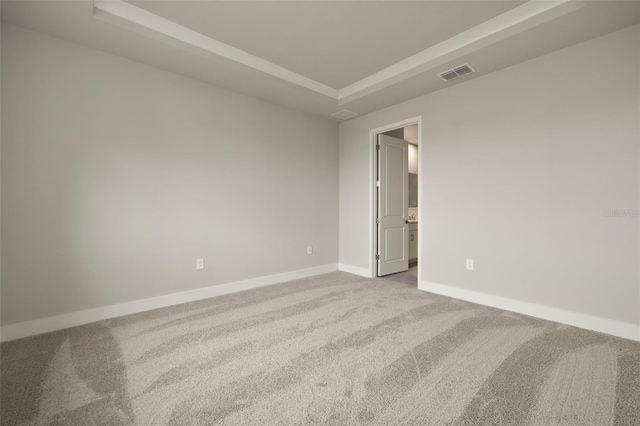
0, 263, 338, 342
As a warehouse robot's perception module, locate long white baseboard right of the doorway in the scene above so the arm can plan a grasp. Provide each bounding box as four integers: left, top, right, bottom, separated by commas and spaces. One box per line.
418, 281, 640, 341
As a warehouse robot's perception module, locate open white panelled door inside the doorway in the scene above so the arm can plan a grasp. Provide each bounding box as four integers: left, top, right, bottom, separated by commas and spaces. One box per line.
376, 135, 409, 277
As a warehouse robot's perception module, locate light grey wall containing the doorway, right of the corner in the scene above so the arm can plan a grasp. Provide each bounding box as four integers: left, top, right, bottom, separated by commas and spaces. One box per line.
340, 26, 640, 328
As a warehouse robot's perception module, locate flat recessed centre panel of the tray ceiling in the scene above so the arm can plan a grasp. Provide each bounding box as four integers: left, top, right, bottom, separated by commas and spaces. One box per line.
130, 1, 524, 89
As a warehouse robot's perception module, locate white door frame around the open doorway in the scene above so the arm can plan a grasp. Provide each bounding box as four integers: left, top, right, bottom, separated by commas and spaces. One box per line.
369, 115, 424, 285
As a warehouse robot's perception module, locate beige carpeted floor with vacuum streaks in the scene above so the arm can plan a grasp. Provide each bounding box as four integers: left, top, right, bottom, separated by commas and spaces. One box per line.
0, 272, 640, 426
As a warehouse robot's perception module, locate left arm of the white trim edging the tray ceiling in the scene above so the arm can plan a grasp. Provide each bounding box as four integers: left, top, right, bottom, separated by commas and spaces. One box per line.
93, 0, 338, 99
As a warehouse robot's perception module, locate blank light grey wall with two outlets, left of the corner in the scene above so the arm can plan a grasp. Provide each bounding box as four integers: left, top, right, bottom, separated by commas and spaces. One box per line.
1, 25, 338, 326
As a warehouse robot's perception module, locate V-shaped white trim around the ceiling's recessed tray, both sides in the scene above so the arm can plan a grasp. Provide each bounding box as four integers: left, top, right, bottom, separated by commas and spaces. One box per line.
93, 0, 585, 105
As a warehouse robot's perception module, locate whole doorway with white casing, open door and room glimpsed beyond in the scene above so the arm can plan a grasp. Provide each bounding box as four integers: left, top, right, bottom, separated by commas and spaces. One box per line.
370, 117, 422, 285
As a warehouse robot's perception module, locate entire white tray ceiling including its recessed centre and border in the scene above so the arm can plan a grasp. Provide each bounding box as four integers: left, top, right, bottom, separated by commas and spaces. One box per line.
2, 0, 640, 117
